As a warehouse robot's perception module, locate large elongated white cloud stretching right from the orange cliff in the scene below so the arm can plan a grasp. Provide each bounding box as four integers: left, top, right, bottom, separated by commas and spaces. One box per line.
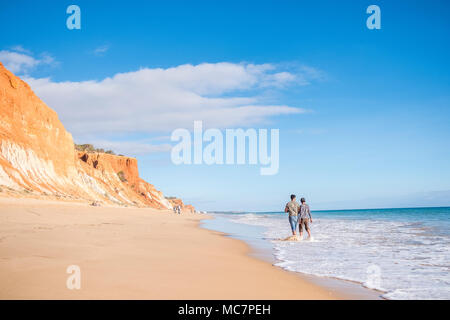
24, 62, 320, 152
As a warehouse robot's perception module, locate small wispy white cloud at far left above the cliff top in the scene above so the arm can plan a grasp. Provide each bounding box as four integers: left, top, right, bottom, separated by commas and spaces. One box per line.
0, 46, 56, 74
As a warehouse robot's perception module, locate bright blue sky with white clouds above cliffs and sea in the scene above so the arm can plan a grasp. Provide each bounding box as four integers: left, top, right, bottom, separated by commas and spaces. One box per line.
0, 0, 450, 211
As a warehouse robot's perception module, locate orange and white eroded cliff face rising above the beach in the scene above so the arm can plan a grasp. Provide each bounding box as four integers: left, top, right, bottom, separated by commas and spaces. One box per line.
0, 63, 191, 210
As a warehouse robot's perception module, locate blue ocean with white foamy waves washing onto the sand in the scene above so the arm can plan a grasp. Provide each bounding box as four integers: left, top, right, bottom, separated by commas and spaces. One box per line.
205, 207, 450, 299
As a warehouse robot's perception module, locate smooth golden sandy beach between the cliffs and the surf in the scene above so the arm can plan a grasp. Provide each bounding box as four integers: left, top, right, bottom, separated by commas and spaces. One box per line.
0, 198, 345, 299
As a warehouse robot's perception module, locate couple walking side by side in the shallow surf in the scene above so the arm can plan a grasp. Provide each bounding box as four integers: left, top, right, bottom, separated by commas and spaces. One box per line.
284, 194, 312, 239
